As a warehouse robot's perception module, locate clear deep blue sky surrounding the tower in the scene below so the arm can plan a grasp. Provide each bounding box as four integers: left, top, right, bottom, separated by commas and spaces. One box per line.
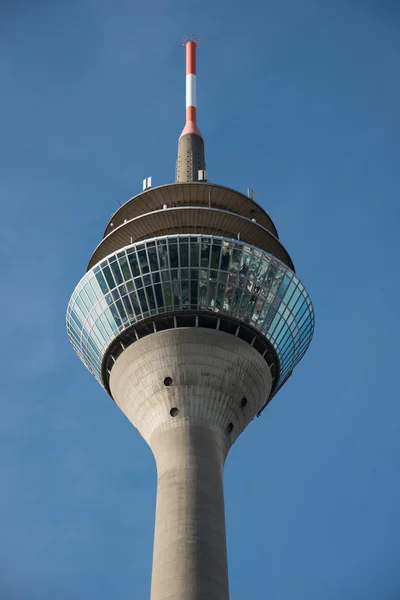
0, 0, 400, 600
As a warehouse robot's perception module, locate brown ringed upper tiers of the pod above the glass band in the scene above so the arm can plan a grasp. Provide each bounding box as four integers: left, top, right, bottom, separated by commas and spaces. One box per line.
88, 182, 294, 270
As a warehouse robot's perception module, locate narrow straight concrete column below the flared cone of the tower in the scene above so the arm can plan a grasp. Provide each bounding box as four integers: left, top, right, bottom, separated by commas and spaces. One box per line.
150, 420, 229, 600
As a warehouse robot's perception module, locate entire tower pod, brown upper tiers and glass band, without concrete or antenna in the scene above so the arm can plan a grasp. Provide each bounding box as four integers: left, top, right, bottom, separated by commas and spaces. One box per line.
67, 182, 314, 409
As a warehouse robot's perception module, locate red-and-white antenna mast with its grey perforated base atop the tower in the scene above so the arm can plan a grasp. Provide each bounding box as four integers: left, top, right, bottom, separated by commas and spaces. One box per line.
176, 33, 207, 183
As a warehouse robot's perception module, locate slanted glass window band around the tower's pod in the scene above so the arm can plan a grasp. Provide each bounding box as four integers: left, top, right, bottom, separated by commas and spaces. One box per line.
67, 234, 314, 404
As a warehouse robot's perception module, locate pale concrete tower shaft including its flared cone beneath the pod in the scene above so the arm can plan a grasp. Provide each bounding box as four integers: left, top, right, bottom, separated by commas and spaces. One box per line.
110, 328, 272, 600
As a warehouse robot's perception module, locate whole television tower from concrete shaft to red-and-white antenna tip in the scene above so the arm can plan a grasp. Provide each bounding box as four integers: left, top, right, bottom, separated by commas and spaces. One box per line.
67, 35, 314, 600
